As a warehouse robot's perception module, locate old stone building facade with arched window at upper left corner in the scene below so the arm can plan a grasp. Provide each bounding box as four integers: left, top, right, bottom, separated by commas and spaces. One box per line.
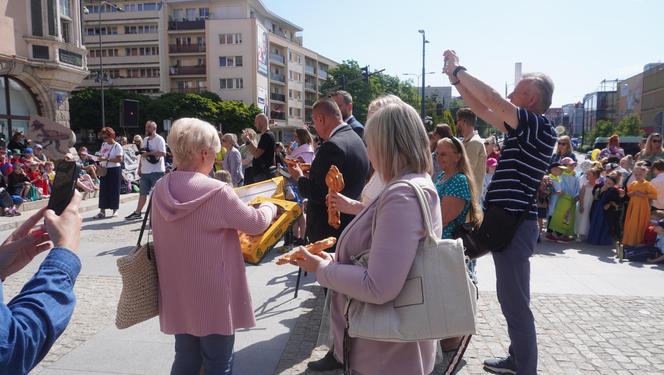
0, 0, 88, 140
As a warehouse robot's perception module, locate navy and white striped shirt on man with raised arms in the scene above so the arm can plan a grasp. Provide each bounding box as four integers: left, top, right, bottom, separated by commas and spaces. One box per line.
486, 108, 556, 220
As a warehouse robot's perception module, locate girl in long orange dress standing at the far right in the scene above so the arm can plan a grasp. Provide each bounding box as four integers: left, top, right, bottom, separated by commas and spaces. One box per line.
623, 165, 657, 246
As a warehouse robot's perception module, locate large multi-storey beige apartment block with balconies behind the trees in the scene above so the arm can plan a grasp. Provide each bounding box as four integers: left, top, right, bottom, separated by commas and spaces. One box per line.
85, 0, 336, 126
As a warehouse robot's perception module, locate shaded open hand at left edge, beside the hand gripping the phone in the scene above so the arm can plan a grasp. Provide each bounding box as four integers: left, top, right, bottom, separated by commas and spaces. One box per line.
0, 208, 53, 280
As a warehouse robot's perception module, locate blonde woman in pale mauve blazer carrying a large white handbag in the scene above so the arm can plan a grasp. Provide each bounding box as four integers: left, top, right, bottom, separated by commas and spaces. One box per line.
296, 103, 442, 375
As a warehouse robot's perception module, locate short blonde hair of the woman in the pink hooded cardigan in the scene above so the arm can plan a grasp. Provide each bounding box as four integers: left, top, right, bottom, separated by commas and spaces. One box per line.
167, 117, 221, 165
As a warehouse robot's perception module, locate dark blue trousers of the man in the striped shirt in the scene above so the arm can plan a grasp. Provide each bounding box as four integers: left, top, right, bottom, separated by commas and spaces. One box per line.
492, 220, 539, 375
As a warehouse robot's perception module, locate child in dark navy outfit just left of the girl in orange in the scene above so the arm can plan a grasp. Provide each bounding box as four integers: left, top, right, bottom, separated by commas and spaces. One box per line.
587, 172, 621, 245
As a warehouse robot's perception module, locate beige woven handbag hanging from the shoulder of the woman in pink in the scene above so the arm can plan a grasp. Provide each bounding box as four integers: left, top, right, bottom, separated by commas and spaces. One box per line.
115, 200, 159, 329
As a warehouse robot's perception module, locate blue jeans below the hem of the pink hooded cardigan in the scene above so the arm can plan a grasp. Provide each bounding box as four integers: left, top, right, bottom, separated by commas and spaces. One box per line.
171, 334, 235, 375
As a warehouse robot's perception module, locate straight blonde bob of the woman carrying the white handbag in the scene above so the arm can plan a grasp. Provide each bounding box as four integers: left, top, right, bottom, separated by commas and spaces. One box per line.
364, 103, 432, 182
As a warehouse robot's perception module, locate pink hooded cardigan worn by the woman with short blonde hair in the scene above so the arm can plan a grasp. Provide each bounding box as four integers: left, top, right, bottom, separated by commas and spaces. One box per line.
151, 171, 276, 336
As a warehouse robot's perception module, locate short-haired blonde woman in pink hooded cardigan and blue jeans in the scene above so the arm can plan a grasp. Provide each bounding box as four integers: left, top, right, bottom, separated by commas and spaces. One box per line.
151, 118, 277, 374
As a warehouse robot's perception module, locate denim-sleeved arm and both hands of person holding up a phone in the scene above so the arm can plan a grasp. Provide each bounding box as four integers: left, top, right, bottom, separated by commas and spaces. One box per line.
0, 195, 81, 374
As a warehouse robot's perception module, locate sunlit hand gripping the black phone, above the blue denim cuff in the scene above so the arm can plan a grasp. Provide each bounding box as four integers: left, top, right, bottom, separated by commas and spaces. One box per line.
44, 192, 81, 251
